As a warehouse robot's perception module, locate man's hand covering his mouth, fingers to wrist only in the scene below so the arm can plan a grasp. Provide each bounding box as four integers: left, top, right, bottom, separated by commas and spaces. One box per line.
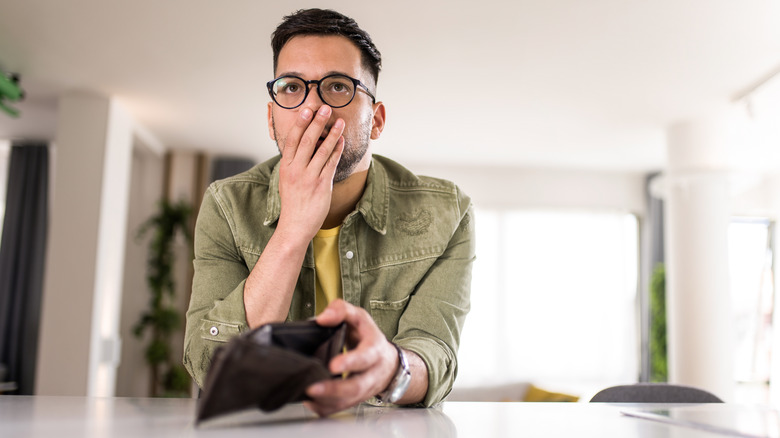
278, 105, 344, 243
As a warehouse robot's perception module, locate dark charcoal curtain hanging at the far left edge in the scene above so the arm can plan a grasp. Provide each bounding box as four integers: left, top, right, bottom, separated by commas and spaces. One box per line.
0, 144, 49, 394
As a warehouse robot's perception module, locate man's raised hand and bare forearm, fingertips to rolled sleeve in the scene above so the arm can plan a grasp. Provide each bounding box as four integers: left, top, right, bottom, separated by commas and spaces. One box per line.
244, 105, 344, 328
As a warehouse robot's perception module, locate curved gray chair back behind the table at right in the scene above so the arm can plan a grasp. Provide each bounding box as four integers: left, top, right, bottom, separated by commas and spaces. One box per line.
590, 383, 723, 403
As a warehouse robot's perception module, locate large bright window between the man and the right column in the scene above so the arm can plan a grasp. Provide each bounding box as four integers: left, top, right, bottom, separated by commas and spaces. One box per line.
456, 209, 639, 390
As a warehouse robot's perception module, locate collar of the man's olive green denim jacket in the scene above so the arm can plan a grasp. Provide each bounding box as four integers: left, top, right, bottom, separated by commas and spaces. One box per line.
263, 158, 390, 235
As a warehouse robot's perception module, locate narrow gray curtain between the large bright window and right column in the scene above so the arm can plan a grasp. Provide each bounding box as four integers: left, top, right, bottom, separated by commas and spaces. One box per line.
639, 172, 664, 382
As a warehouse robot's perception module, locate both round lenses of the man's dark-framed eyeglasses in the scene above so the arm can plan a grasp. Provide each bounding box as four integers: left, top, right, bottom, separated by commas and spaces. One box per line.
272, 75, 355, 108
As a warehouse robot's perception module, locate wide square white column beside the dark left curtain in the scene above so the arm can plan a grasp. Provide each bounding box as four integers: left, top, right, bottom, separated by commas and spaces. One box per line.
36, 93, 133, 396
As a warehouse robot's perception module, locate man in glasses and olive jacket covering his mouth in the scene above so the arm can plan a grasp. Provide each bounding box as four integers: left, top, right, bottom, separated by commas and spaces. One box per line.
184, 9, 474, 415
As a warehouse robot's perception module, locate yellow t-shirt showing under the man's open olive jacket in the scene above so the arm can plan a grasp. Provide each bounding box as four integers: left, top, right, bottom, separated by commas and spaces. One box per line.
314, 226, 344, 315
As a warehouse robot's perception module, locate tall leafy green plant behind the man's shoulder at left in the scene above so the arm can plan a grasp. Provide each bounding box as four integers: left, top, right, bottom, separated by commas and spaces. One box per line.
133, 200, 192, 397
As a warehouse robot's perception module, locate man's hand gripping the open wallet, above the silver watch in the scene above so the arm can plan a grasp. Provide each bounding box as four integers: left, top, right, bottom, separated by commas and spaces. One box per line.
306, 300, 402, 416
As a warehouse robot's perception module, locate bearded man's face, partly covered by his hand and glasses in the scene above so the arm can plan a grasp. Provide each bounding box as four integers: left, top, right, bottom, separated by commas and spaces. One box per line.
268, 35, 384, 182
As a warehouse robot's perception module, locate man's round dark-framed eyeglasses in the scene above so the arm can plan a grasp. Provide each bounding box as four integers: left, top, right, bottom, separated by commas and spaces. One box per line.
266, 73, 376, 109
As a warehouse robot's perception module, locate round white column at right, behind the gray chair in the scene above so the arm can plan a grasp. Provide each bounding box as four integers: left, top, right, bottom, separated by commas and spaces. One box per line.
665, 110, 735, 401
